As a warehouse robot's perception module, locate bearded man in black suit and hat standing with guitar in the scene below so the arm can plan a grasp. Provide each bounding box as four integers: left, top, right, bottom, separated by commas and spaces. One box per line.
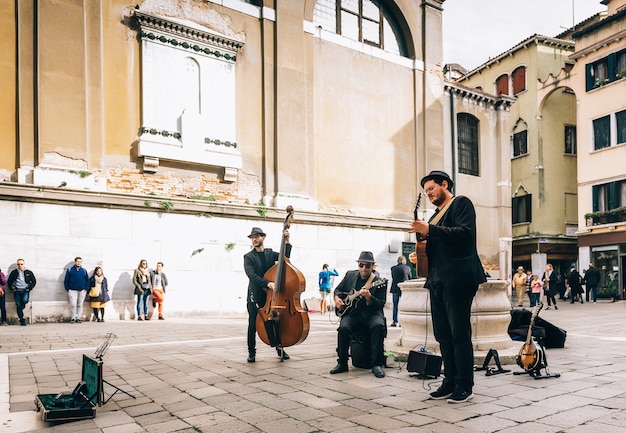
409, 171, 486, 403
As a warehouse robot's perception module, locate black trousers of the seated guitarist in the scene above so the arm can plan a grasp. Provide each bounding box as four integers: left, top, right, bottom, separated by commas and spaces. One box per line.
337, 314, 387, 366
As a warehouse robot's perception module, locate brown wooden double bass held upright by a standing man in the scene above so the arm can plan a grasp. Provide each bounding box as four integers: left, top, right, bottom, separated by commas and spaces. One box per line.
256, 206, 310, 354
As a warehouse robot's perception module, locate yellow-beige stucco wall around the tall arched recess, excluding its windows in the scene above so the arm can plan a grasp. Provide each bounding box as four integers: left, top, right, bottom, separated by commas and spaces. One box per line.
462, 37, 577, 264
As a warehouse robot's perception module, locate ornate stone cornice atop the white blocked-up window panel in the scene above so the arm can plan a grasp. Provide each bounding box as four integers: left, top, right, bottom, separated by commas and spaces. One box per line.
134, 11, 244, 62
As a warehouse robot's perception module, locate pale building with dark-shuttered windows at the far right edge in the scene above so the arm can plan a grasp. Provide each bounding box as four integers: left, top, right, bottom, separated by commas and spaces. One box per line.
572, 0, 626, 299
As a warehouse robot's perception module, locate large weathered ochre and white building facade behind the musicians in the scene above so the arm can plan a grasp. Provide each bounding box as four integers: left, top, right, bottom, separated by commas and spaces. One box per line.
0, 0, 510, 320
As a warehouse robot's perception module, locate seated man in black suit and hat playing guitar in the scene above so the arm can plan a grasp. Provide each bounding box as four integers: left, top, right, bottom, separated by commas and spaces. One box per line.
330, 251, 387, 377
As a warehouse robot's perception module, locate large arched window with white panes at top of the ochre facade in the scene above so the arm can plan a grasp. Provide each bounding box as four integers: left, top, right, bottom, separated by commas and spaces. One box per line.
313, 0, 409, 57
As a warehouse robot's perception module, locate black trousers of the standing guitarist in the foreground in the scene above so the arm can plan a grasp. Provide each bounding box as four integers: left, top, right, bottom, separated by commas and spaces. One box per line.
430, 282, 478, 390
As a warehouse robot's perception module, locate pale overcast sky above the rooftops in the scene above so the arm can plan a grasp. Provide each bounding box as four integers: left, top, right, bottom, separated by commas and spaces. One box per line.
443, 0, 606, 71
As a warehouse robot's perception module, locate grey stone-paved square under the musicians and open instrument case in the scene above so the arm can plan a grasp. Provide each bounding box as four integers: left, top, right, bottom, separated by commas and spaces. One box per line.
0, 302, 626, 433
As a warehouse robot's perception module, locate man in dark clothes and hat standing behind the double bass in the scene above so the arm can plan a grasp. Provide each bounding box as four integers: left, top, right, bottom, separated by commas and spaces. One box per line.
243, 227, 291, 362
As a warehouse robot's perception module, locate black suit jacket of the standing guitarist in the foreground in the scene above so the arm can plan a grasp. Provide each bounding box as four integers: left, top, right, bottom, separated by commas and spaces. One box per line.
426, 195, 487, 288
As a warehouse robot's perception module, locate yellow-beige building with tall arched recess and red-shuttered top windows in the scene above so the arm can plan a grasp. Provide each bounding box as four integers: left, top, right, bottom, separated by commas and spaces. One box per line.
459, 35, 577, 275
